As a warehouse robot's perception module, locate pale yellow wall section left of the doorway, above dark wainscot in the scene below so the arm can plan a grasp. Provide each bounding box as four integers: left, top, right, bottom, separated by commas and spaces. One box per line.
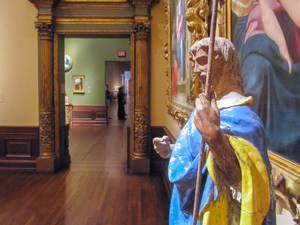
0, 0, 38, 126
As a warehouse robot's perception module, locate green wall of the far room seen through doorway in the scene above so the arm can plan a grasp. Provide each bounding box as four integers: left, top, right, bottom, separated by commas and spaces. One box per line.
65, 38, 131, 105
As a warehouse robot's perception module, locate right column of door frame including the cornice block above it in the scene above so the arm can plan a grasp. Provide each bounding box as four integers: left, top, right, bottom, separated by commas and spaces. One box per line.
129, 0, 158, 173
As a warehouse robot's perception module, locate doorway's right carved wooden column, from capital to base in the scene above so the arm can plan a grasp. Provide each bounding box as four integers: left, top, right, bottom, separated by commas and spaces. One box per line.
130, 21, 150, 173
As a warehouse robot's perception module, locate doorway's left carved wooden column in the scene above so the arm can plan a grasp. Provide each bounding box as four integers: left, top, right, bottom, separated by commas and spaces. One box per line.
36, 7, 57, 172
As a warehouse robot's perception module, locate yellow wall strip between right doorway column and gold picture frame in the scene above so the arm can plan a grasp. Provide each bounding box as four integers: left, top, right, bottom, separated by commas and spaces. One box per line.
151, 0, 180, 138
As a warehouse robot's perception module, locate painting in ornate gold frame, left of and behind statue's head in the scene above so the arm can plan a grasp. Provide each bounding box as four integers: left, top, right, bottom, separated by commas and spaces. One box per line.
165, 0, 228, 128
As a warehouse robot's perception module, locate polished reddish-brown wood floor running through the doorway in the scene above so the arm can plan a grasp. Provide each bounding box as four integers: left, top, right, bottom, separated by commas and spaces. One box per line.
0, 101, 169, 225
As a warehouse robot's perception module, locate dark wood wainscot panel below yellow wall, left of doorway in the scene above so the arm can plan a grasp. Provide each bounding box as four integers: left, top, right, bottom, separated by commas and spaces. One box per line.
0, 127, 39, 170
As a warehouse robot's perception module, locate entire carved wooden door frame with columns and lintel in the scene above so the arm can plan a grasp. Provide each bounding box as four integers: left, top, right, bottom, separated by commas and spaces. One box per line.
29, 0, 158, 173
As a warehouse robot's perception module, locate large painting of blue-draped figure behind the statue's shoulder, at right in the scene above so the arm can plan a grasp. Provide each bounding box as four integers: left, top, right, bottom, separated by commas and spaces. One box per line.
230, 0, 300, 163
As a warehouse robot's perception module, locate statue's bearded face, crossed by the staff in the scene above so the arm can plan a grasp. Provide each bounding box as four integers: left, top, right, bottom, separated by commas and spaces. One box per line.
194, 46, 223, 93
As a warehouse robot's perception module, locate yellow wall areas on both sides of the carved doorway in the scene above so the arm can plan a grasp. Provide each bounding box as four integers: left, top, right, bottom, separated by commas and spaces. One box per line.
0, 0, 179, 137
